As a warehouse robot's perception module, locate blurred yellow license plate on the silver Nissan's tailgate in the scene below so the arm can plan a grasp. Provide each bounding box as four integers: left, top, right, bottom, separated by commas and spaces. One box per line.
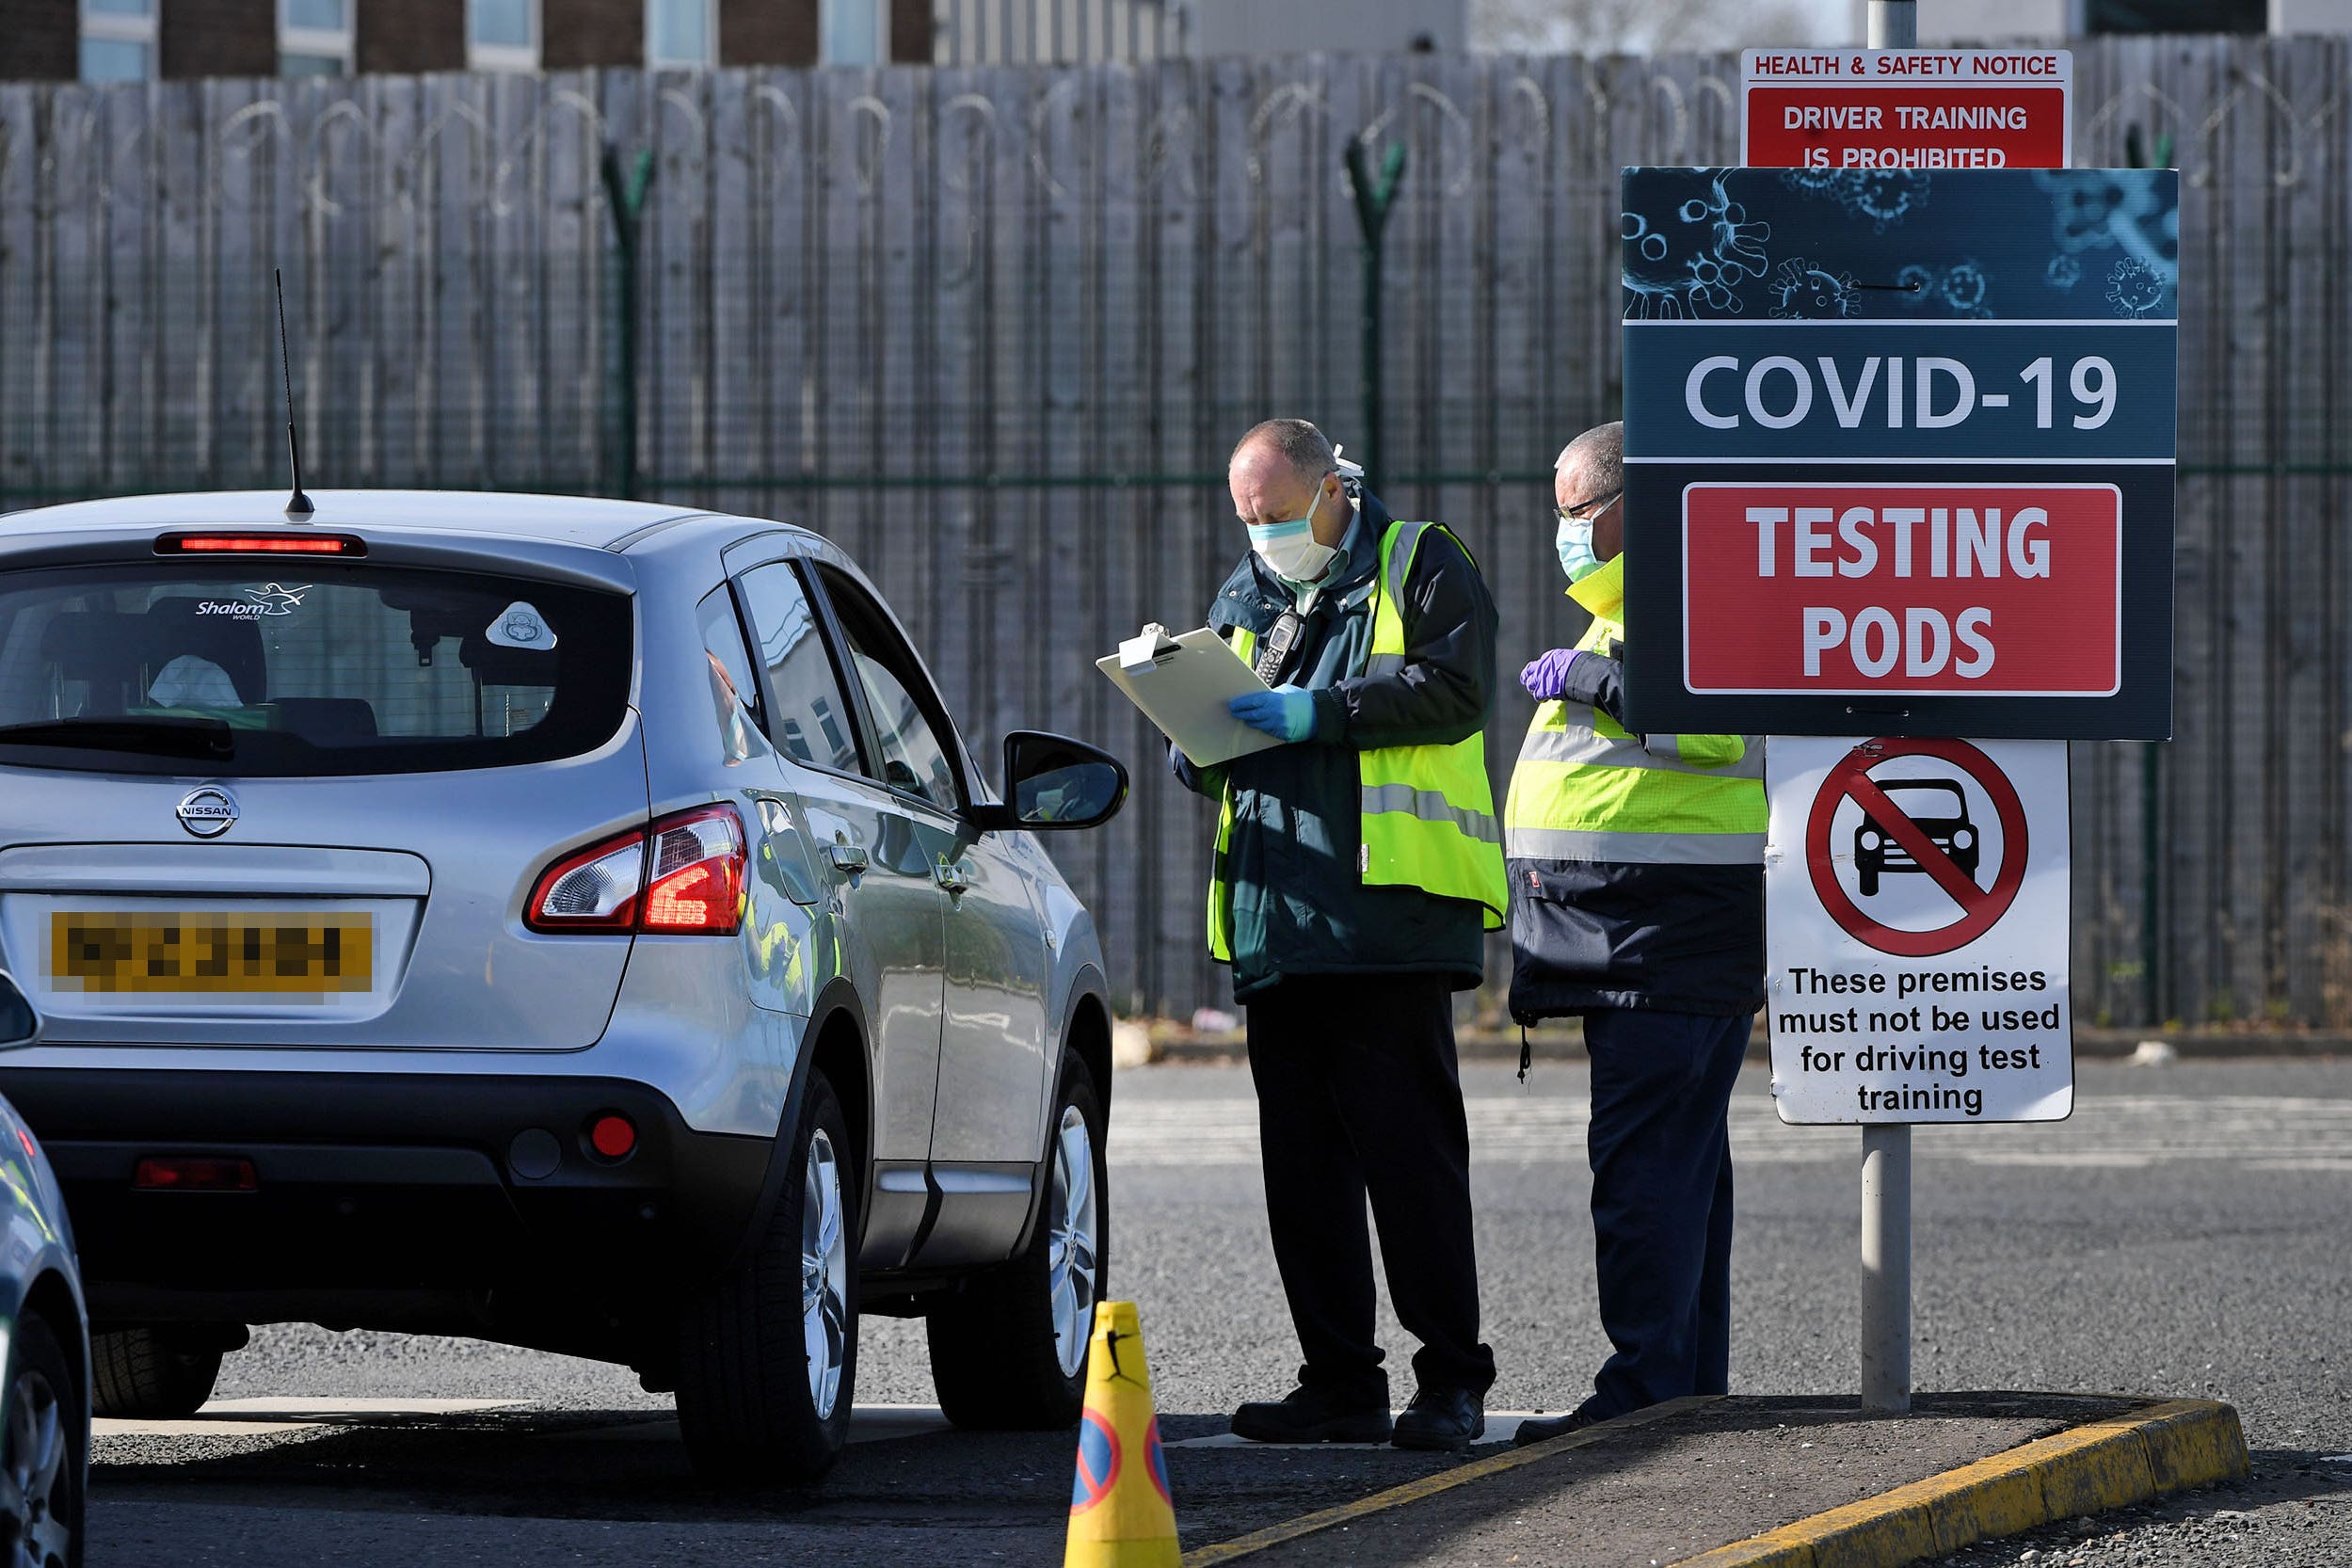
49, 910, 376, 1000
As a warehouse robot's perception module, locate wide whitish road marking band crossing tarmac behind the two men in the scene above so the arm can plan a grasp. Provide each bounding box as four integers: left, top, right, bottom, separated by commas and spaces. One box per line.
1111, 1096, 2352, 1173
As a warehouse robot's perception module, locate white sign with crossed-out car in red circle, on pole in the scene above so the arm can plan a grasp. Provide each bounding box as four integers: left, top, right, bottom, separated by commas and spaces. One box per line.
1764, 736, 2074, 1124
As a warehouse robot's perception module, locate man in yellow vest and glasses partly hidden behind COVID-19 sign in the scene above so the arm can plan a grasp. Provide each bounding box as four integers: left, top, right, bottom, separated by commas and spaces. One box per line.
1503, 424, 1764, 1444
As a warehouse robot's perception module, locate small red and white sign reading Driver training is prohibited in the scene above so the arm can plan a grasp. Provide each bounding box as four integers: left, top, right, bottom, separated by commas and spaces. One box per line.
1740, 49, 2074, 169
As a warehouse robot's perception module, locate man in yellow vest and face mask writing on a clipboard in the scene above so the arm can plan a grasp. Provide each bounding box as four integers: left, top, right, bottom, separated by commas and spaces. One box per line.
1169, 419, 1505, 1448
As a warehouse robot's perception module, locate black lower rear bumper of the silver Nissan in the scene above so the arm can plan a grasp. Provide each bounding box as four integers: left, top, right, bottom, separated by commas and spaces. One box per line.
0, 1067, 772, 1342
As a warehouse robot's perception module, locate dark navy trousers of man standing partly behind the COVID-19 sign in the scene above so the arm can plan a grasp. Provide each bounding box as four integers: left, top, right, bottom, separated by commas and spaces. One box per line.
1583, 1009, 1748, 1420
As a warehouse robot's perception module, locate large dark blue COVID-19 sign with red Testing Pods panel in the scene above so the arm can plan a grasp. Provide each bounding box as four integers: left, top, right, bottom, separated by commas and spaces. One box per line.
1623, 169, 2181, 741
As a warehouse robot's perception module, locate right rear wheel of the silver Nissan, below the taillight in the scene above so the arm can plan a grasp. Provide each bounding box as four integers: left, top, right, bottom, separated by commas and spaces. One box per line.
678, 1072, 863, 1486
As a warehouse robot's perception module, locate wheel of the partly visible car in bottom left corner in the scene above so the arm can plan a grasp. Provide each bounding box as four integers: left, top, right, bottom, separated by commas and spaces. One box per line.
0, 1312, 89, 1568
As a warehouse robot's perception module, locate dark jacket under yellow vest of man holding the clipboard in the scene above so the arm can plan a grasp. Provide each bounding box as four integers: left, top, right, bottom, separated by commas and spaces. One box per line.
1169, 496, 1496, 1001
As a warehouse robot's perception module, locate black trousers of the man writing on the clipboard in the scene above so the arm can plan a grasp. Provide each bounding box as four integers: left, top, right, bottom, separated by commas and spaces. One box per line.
1249, 976, 1494, 1406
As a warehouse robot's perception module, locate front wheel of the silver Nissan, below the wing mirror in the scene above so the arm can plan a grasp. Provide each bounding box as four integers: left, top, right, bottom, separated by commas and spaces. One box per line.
927, 1055, 1111, 1432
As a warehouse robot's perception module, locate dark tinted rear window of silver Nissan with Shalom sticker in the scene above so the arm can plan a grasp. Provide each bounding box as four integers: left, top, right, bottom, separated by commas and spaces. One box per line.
0, 559, 632, 776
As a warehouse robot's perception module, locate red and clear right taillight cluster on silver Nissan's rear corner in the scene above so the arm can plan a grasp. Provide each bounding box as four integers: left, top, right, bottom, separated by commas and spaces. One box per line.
522, 807, 745, 936
